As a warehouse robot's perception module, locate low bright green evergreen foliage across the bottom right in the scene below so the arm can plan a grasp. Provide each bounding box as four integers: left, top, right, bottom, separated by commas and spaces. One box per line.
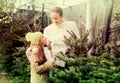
49, 51, 120, 83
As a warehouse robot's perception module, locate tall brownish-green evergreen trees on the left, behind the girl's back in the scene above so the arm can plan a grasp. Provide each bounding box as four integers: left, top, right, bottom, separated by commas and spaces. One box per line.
0, 3, 30, 83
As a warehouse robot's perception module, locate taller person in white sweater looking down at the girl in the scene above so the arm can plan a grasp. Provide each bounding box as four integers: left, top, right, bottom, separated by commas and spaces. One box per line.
44, 7, 80, 67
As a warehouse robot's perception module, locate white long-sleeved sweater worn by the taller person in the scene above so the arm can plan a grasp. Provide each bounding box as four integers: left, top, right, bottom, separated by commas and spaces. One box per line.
44, 20, 80, 55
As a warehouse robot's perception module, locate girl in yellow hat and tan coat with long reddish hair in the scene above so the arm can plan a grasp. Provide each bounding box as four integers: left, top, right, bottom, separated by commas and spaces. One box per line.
25, 32, 56, 83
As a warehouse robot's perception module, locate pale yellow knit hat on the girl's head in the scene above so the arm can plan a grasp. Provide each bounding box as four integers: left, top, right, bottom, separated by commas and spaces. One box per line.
25, 32, 43, 44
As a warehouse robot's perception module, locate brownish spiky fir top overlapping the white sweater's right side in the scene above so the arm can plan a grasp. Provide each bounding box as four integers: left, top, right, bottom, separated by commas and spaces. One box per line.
64, 31, 89, 56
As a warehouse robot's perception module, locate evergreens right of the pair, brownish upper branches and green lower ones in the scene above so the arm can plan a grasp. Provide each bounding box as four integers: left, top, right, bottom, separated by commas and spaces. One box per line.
49, 25, 120, 83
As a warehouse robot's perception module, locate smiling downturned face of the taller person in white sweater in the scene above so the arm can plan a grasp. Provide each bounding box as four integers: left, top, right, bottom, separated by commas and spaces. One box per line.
50, 12, 63, 25
